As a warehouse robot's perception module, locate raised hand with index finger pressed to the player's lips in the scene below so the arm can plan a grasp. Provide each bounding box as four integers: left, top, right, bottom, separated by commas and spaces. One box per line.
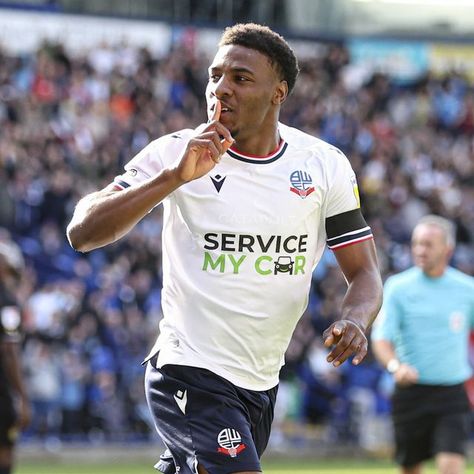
176, 100, 234, 182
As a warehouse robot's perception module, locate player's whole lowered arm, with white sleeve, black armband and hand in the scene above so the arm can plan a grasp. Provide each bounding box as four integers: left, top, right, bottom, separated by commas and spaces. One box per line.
323, 147, 383, 366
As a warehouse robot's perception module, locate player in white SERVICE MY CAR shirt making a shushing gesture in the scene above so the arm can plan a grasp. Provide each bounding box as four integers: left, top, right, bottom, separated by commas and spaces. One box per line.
68, 24, 382, 474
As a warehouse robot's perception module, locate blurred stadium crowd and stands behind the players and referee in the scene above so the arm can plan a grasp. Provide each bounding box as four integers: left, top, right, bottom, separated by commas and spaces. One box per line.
0, 0, 474, 470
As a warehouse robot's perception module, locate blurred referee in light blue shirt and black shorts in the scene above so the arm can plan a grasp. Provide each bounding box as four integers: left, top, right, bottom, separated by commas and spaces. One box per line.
372, 216, 474, 474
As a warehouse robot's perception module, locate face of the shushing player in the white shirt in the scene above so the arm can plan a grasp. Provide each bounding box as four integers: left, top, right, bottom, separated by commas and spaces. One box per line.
206, 45, 287, 141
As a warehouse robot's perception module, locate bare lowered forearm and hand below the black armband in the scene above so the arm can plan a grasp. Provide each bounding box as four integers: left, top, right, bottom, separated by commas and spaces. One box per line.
323, 238, 383, 366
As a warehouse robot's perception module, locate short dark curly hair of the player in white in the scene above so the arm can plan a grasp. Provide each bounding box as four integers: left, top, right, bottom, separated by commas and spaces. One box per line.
219, 23, 299, 93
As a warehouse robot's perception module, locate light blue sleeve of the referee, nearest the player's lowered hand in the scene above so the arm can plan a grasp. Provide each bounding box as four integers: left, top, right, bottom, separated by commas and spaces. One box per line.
372, 278, 402, 343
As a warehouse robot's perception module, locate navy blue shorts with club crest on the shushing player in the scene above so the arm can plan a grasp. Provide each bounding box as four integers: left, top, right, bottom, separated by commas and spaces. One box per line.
145, 357, 278, 474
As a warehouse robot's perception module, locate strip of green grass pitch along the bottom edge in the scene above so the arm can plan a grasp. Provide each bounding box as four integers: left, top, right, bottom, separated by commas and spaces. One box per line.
15, 459, 458, 474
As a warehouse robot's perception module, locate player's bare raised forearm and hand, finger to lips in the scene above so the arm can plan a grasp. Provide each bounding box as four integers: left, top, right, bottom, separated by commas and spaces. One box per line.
67, 102, 233, 252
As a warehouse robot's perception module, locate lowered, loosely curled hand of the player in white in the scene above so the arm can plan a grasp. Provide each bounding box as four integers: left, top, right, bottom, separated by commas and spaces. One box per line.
323, 319, 368, 367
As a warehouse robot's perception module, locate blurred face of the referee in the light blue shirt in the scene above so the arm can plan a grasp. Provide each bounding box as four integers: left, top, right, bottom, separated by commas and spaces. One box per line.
411, 224, 452, 277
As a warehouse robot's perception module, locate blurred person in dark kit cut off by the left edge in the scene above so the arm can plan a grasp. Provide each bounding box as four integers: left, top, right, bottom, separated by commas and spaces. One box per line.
0, 241, 30, 474
